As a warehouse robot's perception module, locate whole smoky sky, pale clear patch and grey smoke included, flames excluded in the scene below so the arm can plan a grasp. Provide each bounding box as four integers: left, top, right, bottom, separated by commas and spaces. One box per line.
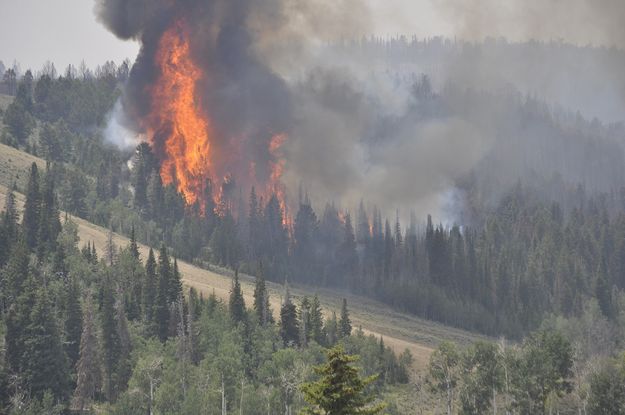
0, 0, 625, 224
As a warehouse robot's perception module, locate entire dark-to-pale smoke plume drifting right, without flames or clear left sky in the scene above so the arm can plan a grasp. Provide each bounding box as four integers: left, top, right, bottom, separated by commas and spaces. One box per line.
96, 0, 625, 224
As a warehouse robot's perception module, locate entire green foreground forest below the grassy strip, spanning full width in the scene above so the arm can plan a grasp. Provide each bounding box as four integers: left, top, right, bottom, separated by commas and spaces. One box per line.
0, 171, 625, 414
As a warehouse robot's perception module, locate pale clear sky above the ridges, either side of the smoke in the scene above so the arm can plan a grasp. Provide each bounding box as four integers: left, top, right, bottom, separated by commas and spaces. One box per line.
0, 0, 625, 69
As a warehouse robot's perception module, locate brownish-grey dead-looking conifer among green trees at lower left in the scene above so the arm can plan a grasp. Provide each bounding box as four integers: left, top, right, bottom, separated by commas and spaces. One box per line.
73, 297, 102, 412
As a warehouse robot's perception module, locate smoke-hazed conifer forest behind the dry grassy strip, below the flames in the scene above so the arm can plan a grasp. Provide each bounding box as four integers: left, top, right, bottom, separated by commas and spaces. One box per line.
2, 57, 625, 338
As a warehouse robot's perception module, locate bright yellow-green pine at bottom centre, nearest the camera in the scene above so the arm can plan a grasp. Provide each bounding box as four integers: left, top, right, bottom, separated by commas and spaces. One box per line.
301, 346, 385, 415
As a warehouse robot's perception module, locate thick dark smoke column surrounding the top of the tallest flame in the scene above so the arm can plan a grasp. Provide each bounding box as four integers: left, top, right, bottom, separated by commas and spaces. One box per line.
96, 0, 292, 186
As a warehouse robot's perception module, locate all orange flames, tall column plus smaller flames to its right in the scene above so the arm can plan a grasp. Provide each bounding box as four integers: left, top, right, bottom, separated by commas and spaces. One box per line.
143, 19, 289, 218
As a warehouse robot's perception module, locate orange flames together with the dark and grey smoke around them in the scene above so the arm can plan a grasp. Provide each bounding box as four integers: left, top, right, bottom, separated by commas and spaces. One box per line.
96, 0, 622, 228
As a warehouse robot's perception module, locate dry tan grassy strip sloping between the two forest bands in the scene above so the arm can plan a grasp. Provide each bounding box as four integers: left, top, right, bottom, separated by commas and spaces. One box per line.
0, 144, 486, 370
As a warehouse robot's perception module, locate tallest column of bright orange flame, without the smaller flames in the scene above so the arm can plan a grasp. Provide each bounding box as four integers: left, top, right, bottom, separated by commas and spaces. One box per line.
148, 22, 213, 205
